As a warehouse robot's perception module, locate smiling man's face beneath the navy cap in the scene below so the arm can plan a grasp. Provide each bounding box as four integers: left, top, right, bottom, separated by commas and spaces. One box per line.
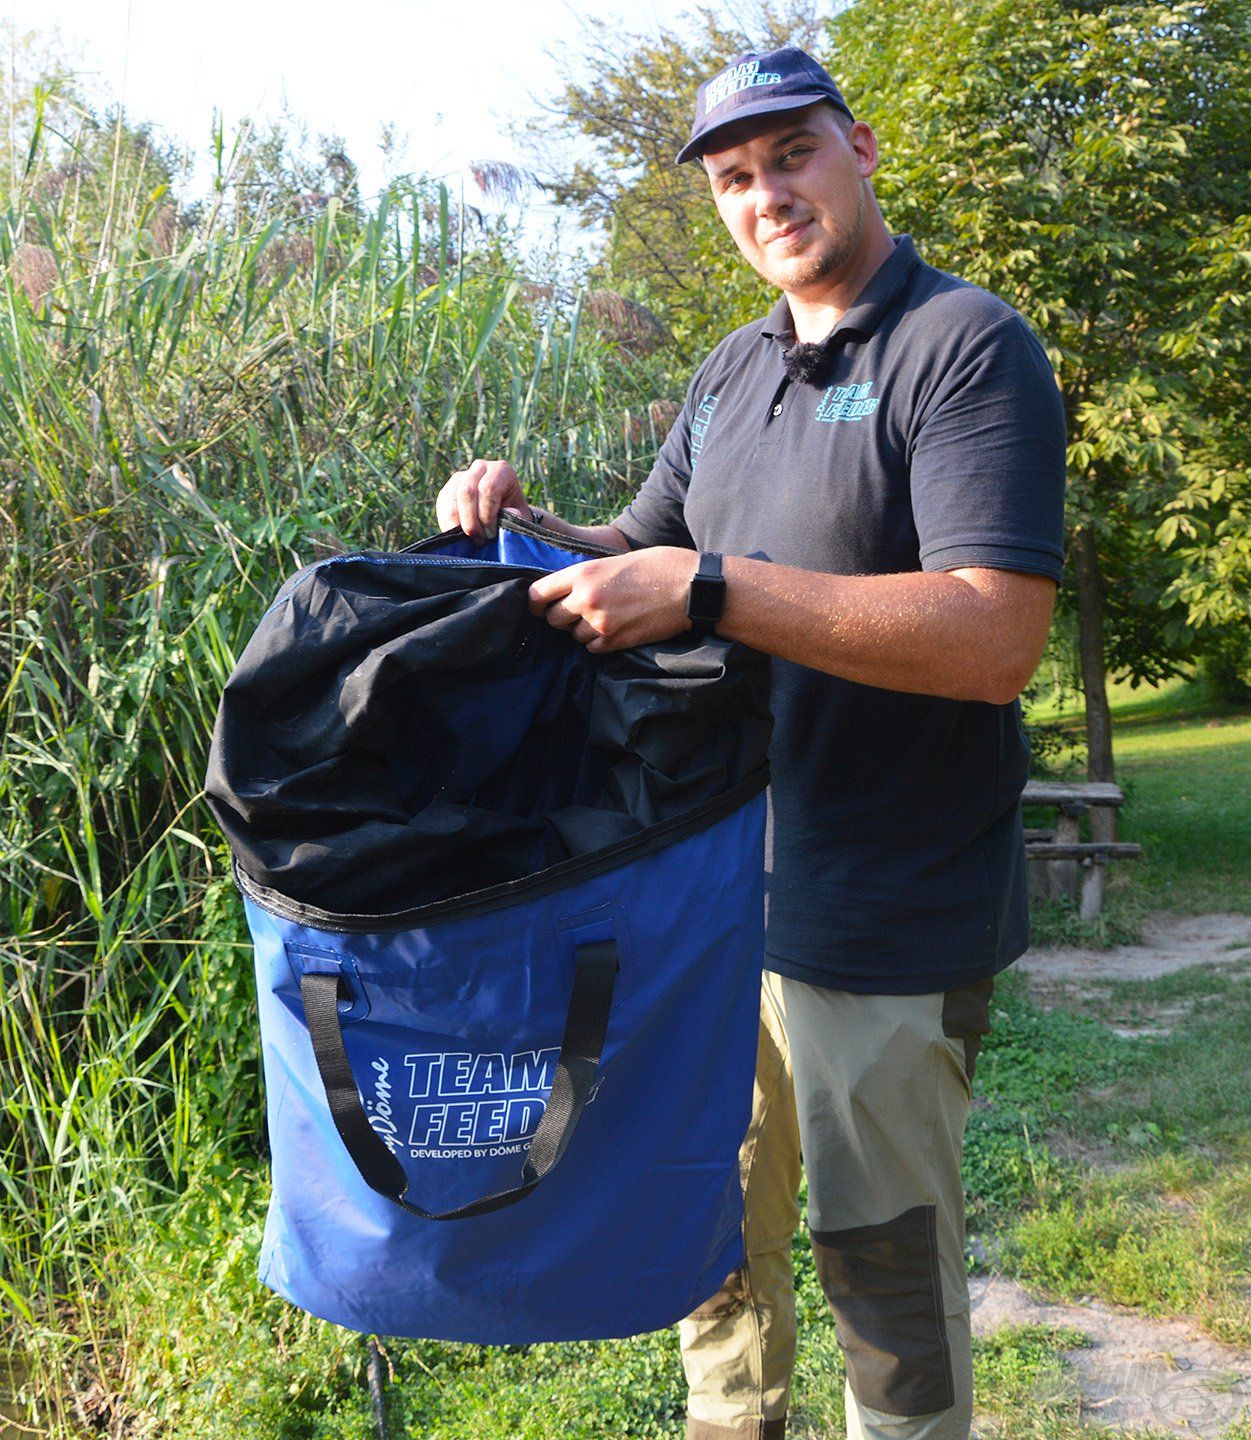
704, 104, 877, 298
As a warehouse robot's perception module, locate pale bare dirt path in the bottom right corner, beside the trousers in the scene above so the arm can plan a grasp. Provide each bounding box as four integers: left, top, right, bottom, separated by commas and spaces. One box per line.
969, 1276, 1251, 1440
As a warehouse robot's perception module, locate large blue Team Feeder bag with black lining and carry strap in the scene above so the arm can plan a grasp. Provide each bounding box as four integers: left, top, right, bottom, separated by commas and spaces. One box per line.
207, 517, 769, 1344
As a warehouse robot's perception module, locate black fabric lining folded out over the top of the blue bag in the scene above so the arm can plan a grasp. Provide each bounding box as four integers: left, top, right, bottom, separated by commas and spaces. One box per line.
206, 535, 770, 932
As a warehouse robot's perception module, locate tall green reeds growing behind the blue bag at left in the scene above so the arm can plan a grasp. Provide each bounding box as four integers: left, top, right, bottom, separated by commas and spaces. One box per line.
0, 129, 673, 1433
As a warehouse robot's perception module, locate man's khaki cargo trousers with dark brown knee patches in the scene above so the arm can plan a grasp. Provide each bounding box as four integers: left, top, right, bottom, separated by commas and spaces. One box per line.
679, 972, 993, 1440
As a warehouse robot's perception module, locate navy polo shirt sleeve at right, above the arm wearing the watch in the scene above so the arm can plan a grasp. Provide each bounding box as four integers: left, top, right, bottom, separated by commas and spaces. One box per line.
911, 314, 1065, 582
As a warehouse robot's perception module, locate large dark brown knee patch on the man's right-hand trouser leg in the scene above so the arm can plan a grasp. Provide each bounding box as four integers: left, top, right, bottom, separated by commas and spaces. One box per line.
812, 1205, 954, 1416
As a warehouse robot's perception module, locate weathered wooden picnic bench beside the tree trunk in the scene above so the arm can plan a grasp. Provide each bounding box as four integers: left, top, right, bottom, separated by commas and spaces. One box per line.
1021, 780, 1143, 920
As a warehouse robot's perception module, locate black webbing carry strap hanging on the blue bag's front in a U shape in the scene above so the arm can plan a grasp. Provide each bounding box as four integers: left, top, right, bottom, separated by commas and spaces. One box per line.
299, 940, 620, 1220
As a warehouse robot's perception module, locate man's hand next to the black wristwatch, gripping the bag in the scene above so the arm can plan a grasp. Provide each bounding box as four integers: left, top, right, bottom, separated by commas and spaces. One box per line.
530, 546, 698, 654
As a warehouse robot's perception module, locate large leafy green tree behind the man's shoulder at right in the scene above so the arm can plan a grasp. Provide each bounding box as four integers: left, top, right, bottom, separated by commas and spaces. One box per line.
829, 0, 1251, 779
